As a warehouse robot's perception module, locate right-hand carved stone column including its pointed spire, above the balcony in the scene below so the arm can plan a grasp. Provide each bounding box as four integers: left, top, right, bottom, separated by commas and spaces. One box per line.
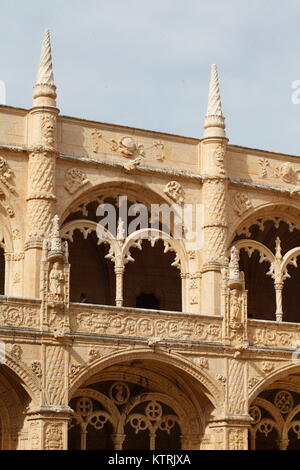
201, 65, 228, 315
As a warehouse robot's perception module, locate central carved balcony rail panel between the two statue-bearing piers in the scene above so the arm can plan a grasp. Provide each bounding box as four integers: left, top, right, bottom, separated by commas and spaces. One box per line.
70, 304, 222, 343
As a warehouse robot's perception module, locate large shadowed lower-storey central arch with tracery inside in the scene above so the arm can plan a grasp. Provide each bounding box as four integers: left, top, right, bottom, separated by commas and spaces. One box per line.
69, 360, 213, 450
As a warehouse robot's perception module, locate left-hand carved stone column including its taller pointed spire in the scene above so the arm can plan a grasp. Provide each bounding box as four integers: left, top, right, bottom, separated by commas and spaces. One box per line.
23, 31, 59, 297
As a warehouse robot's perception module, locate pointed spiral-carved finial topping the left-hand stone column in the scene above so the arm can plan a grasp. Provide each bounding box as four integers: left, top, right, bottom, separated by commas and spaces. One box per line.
33, 29, 56, 107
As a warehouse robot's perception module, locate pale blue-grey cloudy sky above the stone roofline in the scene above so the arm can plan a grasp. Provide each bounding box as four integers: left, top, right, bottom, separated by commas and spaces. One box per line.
0, 0, 300, 155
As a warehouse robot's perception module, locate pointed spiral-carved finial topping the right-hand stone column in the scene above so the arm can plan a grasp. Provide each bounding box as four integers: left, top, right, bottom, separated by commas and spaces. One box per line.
204, 64, 225, 137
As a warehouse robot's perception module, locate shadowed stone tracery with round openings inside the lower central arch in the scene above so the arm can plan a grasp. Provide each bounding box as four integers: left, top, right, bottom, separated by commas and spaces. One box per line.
69, 382, 190, 450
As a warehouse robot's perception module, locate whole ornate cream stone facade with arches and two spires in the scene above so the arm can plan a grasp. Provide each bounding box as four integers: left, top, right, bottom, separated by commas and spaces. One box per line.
0, 31, 300, 450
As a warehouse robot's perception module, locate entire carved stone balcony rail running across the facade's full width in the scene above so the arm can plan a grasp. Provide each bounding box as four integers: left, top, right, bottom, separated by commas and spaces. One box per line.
0, 296, 300, 350
